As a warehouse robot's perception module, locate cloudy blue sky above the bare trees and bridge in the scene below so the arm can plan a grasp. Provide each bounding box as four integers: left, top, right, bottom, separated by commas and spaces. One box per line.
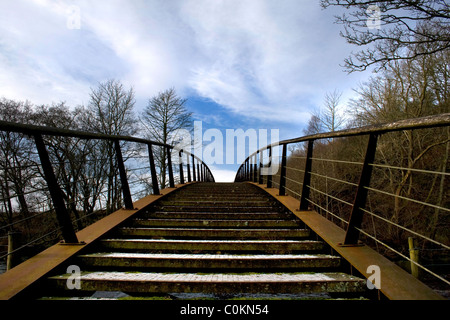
0, 0, 368, 181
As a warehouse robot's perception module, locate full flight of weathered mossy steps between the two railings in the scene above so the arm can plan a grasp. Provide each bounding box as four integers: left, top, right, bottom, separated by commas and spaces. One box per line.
13, 183, 367, 297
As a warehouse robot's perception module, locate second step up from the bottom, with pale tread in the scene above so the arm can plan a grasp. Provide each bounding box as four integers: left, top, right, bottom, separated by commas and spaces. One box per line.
77, 252, 340, 271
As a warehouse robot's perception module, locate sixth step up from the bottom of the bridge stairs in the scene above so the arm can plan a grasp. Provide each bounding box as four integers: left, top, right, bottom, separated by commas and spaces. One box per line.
139, 211, 293, 221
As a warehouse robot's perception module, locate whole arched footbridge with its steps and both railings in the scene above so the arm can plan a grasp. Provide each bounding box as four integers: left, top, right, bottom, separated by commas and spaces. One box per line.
0, 114, 450, 300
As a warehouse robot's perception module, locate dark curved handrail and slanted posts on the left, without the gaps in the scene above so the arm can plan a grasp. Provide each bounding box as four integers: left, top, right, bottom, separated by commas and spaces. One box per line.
0, 120, 214, 248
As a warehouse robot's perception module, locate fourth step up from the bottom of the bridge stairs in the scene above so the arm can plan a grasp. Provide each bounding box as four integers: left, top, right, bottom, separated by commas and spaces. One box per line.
117, 227, 309, 239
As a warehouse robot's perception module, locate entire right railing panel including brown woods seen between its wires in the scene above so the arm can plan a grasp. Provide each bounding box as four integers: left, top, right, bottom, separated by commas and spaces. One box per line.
235, 114, 450, 292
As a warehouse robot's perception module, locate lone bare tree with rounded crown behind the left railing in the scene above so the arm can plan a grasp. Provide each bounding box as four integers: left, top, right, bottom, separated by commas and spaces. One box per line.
141, 88, 192, 187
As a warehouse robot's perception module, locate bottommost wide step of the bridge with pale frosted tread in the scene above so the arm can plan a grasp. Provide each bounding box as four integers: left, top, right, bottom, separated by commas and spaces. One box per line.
48, 271, 367, 294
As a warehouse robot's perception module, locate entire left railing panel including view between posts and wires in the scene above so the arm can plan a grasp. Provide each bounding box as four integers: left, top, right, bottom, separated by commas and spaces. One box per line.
0, 121, 214, 267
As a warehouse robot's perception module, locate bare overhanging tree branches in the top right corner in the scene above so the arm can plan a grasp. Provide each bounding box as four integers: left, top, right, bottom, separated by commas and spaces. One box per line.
321, 0, 450, 72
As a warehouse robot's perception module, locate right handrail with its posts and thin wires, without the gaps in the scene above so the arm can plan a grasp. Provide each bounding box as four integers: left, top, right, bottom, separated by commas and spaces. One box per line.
235, 113, 450, 284
